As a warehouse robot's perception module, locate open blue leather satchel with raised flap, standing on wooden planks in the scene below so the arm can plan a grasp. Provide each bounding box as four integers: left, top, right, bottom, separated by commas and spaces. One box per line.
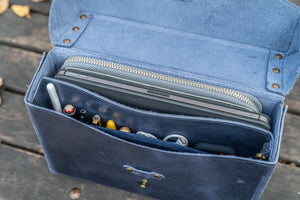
25, 0, 300, 200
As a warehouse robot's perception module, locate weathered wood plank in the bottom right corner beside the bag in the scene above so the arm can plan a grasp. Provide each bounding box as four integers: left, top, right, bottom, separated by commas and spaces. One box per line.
261, 164, 300, 200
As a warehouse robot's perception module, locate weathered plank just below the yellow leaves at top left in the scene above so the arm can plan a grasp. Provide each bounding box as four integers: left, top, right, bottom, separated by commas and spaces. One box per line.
0, 9, 52, 51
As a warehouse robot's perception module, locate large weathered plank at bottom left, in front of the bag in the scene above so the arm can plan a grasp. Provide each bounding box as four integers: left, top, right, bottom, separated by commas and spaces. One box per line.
0, 145, 155, 200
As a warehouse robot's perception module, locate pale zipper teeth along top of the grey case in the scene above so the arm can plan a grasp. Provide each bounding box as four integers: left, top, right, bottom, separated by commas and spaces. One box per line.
65, 56, 257, 108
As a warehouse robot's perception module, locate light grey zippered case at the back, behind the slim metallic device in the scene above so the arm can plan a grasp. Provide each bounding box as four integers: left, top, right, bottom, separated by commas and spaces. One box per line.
61, 56, 262, 112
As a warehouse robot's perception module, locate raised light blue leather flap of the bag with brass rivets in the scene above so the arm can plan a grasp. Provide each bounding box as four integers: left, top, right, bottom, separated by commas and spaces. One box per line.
49, 0, 300, 95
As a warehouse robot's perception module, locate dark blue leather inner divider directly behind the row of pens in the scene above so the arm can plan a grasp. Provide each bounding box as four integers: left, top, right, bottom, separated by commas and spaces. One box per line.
33, 77, 273, 157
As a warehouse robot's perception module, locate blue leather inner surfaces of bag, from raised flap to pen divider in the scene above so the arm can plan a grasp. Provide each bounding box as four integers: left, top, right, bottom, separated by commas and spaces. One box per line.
26, 0, 300, 162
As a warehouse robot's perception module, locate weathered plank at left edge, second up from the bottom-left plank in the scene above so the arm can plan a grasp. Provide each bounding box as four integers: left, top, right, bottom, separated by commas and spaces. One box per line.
0, 91, 41, 151
